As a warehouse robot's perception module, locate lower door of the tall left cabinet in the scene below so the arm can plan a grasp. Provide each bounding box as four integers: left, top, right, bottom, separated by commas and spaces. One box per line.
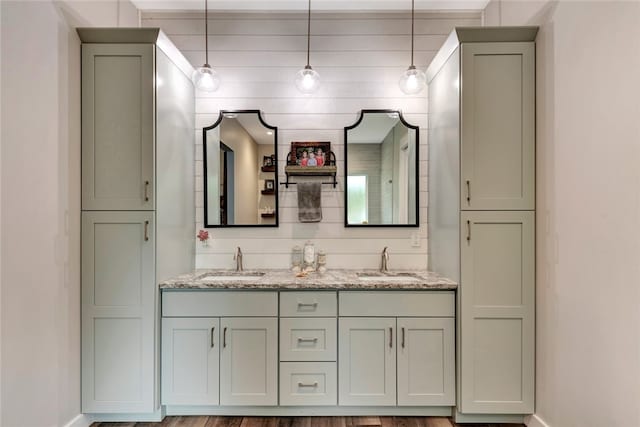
82, 212, 157, 413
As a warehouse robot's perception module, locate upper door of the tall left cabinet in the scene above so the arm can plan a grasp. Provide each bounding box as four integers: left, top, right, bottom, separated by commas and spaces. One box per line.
82, 44, 155, 210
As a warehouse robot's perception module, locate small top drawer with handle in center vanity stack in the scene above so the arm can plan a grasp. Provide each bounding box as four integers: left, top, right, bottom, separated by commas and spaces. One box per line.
280, 292, 338, 317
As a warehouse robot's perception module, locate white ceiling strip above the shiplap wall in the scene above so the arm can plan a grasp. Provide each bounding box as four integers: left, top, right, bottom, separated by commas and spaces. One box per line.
131, 0, 489, 12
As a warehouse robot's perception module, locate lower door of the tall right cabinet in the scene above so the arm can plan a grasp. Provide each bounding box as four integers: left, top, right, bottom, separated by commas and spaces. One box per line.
458, 212, 535, 414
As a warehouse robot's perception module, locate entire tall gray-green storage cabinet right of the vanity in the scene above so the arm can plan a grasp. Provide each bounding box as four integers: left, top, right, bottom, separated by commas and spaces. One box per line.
427, 27, 537, 422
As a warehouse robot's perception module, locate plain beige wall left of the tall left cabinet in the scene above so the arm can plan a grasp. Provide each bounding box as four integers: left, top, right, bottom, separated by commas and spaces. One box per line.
0, 0, 137, 427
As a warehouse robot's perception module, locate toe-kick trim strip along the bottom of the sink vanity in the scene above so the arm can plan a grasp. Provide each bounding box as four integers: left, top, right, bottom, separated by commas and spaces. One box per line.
165, 405, 452, 417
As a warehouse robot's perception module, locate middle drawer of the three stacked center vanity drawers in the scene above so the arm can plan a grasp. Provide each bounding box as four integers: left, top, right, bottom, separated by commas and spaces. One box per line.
280, 317, 337, 362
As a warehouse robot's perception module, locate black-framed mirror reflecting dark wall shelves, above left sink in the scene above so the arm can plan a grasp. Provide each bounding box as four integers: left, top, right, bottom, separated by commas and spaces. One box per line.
202, 110, 278, 228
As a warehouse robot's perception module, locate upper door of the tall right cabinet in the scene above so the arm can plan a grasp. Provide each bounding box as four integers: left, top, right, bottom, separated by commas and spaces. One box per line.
460, 42, 535, 210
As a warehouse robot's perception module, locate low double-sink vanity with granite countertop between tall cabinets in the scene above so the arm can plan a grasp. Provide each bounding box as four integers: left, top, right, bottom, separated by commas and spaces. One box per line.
160, 270, 456, 415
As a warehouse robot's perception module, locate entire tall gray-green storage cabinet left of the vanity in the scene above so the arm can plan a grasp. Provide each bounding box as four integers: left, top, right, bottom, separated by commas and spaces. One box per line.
78, 28, 195, 420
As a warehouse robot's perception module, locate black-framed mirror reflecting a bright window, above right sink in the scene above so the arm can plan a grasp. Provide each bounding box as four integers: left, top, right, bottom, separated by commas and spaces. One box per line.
344, 110, 420, 227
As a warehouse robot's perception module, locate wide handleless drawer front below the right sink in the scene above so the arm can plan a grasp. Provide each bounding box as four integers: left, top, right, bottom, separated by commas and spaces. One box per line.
339, 291, 455, 317
